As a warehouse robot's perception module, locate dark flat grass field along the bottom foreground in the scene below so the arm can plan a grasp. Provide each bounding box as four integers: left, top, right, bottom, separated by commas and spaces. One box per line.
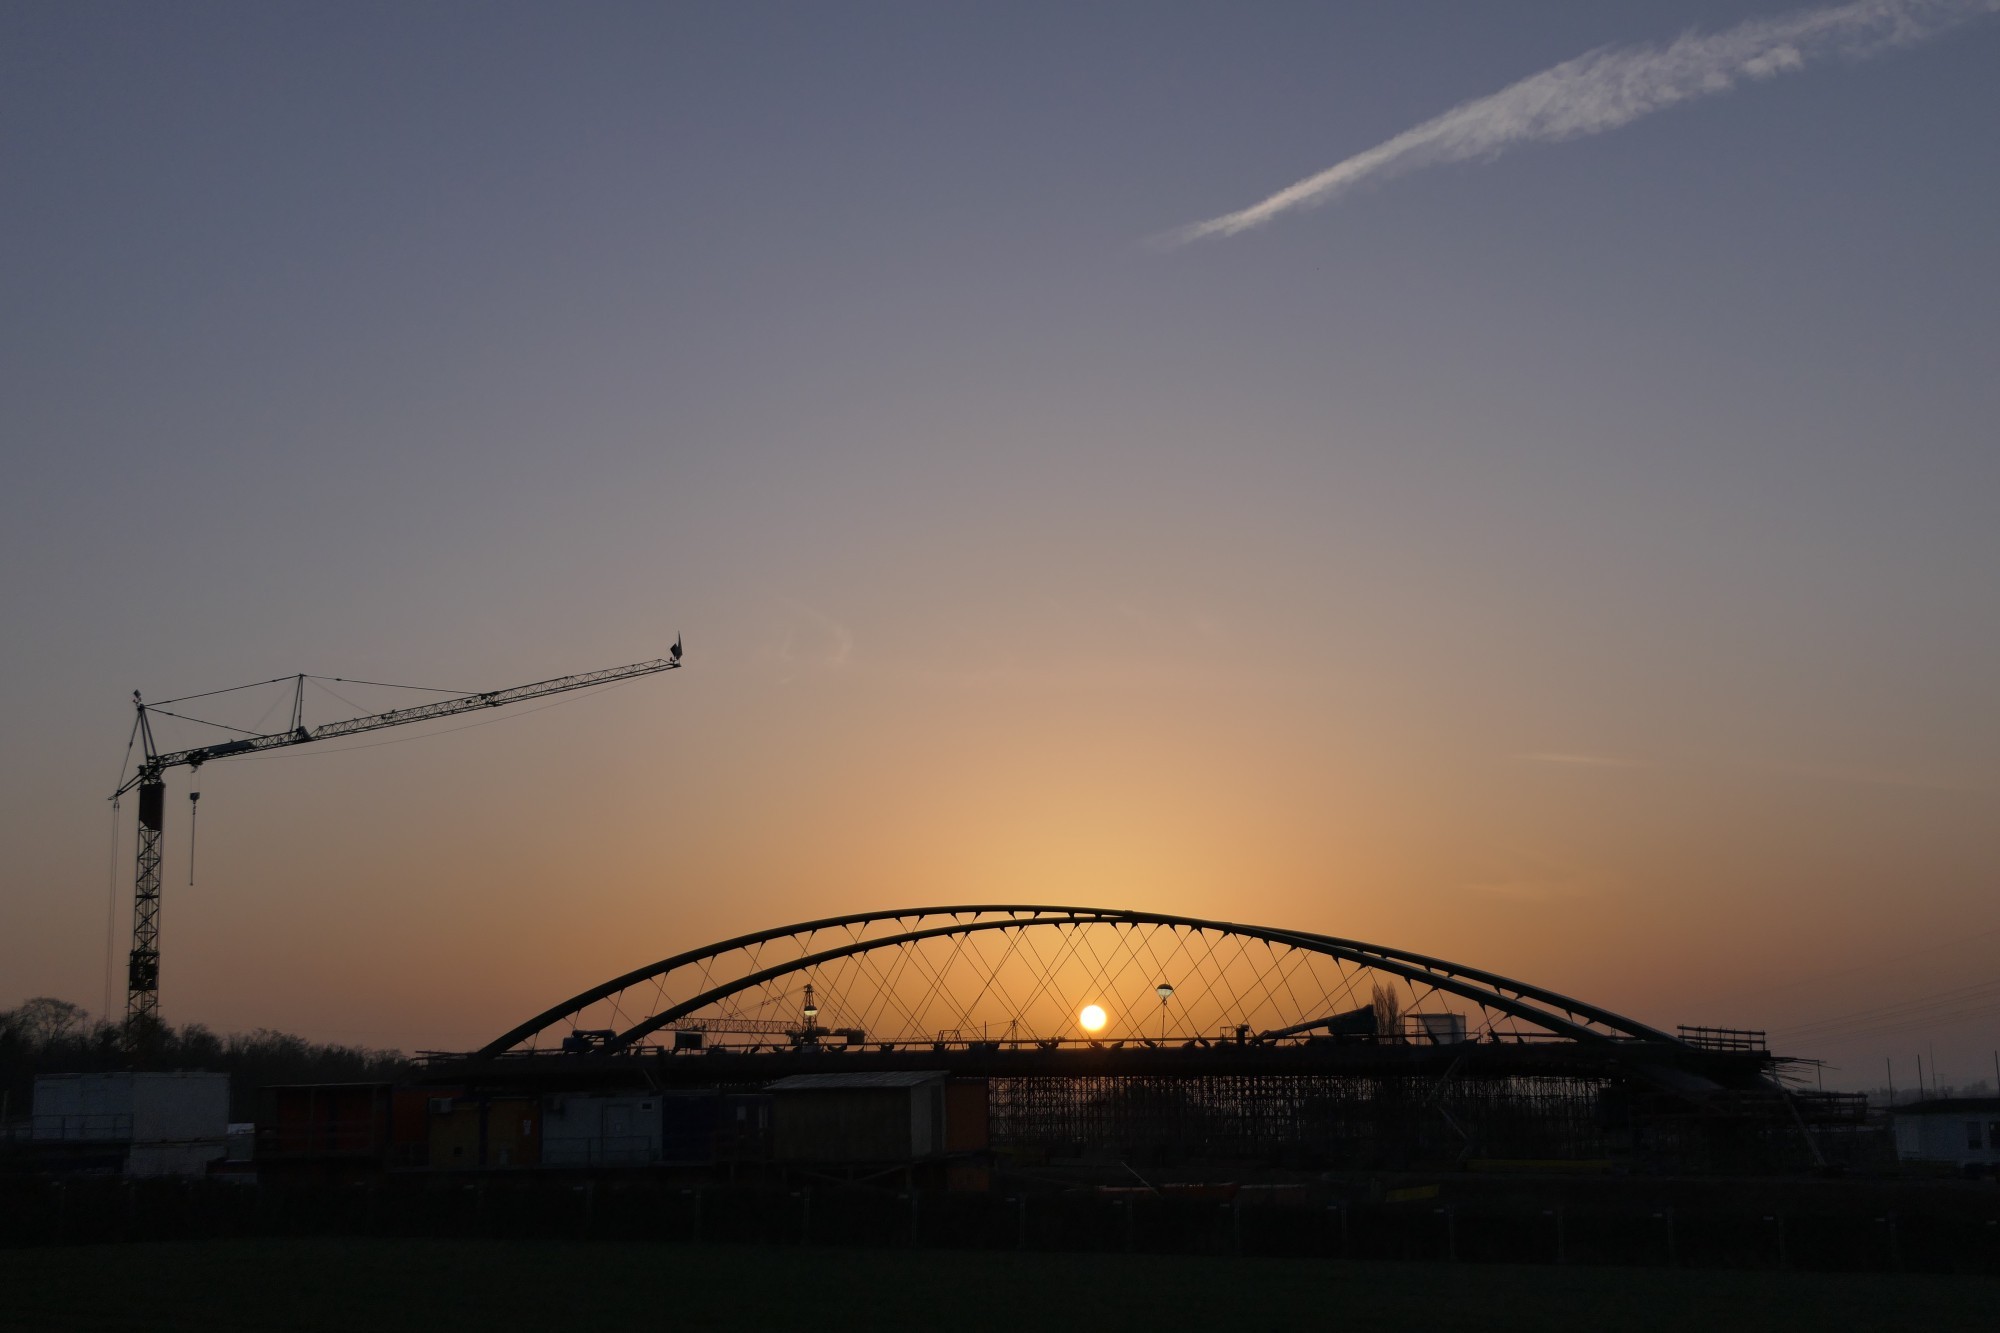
0, 1239, 2000, 1333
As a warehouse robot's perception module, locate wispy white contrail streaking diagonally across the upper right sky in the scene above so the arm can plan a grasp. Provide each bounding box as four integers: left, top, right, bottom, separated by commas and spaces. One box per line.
1158, 0, 2000, 246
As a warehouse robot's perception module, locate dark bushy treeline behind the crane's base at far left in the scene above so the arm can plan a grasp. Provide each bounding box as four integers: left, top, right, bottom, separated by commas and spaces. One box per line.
0, 997, 410, 1121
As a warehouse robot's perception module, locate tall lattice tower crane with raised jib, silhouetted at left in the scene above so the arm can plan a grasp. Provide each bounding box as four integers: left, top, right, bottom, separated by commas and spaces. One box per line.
110, 636, 680, 1045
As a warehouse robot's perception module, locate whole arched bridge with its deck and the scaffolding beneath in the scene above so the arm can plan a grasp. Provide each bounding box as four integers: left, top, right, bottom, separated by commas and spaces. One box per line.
442, 903, 1816, 1165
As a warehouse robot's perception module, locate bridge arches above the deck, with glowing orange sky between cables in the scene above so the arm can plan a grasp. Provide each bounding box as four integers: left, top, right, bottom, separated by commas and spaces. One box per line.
476, 903, 1736, 1057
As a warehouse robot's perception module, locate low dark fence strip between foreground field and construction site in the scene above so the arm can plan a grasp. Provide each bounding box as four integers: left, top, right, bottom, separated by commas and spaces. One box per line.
0, 1177, 2000, 1273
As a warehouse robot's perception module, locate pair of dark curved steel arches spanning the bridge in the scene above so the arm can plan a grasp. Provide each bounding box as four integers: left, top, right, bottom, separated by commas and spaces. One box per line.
478, 903, 1684, 1057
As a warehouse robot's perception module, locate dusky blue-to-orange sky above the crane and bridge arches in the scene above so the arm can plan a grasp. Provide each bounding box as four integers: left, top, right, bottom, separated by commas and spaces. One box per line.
0, 0, 2000, 1087
